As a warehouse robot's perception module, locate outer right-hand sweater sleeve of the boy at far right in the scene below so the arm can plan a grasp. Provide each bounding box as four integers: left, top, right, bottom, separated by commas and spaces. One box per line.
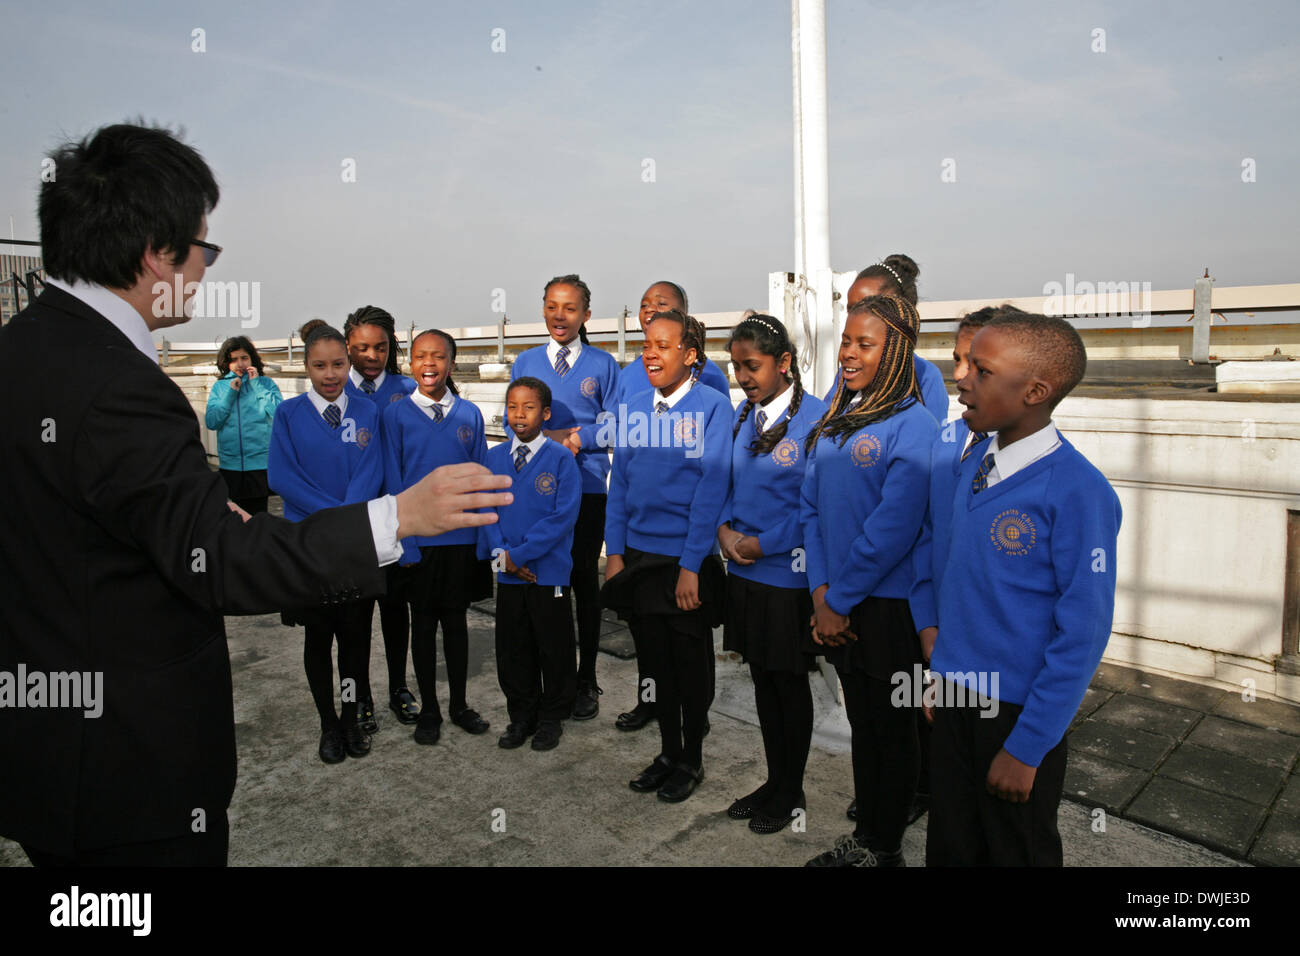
998, 475, 1119, 767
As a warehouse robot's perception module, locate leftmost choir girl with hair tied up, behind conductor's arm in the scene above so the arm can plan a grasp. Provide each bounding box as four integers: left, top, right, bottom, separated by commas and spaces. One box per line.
268, 320, 384, 763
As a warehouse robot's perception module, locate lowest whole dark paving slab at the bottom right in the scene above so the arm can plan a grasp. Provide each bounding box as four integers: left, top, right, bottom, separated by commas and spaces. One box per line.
1125, 777, 1266, 857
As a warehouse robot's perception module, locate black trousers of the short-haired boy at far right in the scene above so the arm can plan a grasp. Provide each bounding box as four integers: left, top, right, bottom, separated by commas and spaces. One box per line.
926, 682, 1067, 866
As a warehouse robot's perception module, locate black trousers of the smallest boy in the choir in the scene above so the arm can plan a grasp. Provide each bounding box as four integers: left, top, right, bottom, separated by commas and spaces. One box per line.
495, 583, 577, 728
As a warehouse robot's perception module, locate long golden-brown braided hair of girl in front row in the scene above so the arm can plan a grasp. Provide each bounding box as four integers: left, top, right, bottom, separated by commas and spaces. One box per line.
806, 295, 924, 453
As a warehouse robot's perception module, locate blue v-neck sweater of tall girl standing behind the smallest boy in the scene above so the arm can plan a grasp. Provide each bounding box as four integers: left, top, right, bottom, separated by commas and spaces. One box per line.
507, 345, 619, 494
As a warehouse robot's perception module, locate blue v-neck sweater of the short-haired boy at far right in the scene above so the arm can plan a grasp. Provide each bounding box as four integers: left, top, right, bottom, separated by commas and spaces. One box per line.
931, 437, 1121, 766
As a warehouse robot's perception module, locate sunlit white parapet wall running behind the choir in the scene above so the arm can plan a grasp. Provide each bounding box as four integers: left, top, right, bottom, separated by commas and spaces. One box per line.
176, 376, 1300, 702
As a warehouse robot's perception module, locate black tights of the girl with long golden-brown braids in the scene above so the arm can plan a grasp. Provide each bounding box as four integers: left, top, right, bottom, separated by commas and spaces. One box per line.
836, 669, 920, 853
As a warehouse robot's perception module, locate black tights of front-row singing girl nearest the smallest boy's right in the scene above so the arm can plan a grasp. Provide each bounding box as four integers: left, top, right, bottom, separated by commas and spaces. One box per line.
629, 610, 714, 769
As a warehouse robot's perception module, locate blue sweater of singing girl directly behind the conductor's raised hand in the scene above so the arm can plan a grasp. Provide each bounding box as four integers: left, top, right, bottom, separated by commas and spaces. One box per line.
381, 398, 488, 564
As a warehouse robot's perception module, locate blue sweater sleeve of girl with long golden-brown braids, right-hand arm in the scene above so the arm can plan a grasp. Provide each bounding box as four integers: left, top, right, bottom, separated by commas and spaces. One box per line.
809, 428, 933, 614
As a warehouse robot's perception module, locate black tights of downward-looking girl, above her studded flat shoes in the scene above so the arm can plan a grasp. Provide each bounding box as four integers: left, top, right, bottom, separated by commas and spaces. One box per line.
749, 662, 813, 817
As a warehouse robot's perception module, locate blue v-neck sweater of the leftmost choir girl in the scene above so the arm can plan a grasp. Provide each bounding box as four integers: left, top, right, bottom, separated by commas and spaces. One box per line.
267, 394, 384, 522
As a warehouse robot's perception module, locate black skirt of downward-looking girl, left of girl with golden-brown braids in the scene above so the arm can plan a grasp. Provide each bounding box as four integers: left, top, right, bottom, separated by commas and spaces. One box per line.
723, 574, 813, 674
